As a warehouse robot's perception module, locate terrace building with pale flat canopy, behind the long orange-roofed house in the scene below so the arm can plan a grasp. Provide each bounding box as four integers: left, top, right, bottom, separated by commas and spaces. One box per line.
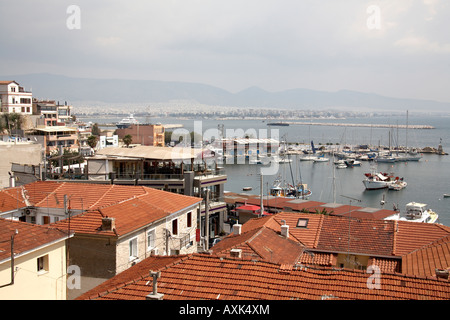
85, 146, 228, 248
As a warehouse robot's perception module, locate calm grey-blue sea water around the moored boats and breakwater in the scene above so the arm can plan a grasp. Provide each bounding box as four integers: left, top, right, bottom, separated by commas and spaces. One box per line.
79, 112, 450, 226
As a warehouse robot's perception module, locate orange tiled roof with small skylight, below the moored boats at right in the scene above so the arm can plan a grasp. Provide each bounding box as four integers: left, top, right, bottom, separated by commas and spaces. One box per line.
237, 212, 450, 257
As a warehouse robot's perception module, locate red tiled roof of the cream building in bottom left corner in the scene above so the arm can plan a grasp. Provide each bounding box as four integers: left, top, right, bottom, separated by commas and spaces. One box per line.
0, 218, 67, 261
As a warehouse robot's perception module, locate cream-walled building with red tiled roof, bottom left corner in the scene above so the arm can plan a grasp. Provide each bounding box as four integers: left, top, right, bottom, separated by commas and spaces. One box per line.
0, 218, 73, 300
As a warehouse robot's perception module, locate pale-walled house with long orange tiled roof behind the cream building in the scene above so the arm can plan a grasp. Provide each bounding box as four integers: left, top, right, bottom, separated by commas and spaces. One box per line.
0, 181, 202, 299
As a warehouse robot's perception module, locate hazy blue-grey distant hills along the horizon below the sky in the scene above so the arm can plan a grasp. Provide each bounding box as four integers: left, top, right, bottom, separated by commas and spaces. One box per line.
0, 73, 450, 112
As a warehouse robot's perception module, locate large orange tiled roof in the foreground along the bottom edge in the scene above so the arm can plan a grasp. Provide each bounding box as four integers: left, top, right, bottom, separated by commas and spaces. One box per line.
78, 254, 450, 300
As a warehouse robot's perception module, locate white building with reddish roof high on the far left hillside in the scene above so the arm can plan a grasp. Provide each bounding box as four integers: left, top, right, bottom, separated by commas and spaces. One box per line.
0, 81, 33, 114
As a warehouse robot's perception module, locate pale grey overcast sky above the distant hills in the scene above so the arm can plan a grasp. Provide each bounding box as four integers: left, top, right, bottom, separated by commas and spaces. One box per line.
0, 0, 450, 102
